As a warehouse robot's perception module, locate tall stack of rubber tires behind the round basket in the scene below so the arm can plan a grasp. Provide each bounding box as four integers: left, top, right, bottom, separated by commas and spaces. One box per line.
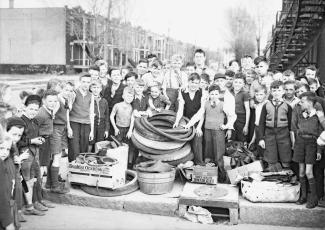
132, 111, 195, 166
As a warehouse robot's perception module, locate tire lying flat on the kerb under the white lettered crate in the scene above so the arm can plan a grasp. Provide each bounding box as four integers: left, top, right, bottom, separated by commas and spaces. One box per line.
80, 170, 139, 197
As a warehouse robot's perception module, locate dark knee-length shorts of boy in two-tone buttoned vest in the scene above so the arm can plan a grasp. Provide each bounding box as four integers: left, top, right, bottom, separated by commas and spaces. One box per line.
264, 127, 292, 164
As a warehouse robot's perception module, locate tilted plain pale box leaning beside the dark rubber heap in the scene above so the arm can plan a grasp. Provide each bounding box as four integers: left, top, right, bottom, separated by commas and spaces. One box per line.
227, 161, 263, 184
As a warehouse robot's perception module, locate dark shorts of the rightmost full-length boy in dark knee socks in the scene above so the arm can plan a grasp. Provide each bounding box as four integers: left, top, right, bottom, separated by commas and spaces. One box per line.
292, 136, 317, 164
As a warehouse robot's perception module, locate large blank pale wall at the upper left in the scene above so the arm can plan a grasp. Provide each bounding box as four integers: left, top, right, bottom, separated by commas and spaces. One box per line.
0, 8, 66, 65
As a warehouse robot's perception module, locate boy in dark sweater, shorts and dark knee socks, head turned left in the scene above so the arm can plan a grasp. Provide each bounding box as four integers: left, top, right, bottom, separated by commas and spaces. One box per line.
291, 92, 325, 208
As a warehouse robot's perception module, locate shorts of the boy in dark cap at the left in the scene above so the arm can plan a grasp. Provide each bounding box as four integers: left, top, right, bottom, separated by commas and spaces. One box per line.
21, 153, 40, 181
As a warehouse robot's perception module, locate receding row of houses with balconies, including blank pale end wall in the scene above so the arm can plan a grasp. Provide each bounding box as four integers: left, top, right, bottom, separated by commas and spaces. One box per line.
0, 7, 216, 73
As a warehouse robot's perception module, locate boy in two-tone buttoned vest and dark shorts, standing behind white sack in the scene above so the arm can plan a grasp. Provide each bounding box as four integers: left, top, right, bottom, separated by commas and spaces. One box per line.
258, 81, 292, 168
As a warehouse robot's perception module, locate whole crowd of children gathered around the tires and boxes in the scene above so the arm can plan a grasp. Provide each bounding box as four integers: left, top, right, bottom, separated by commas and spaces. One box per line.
0, 49, 325, 228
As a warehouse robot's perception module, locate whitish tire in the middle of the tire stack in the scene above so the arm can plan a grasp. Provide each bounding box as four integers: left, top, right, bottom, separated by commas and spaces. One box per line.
132, 130, 185, 150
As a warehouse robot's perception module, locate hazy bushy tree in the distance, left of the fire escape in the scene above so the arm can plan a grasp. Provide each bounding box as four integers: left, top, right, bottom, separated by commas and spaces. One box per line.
228, 7, 256, 60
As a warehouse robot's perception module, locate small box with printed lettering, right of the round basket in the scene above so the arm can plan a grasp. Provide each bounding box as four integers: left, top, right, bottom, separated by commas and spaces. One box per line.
191, 165, 218, 184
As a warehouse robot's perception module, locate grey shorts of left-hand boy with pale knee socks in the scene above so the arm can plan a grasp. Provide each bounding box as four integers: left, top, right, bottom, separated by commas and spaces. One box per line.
50, 125, 68, 155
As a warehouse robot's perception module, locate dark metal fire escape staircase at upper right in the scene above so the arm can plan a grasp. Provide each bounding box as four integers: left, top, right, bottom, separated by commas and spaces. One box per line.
266, 0, 325, 73
